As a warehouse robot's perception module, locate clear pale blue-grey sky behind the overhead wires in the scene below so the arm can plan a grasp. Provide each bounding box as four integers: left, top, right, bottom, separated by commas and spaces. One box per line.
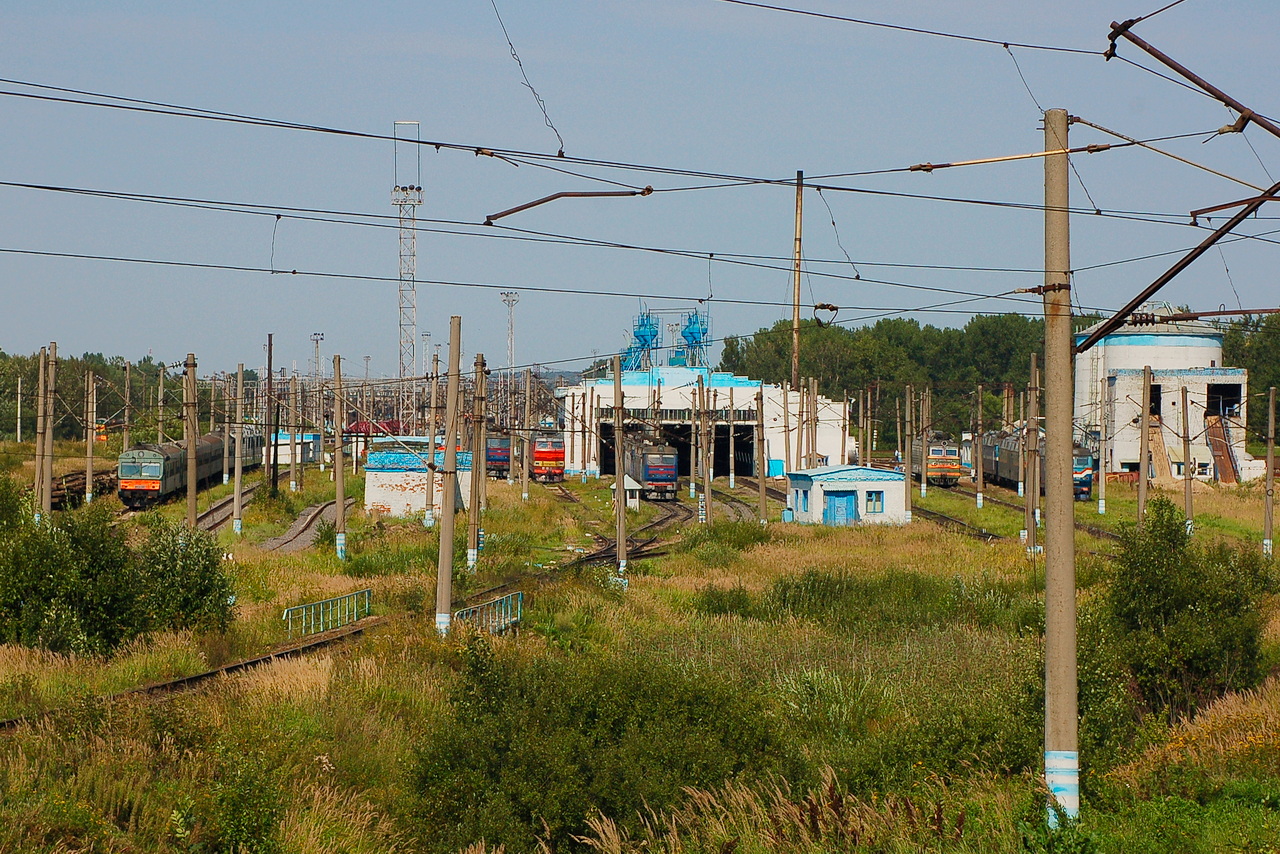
0, 0, 1280, 376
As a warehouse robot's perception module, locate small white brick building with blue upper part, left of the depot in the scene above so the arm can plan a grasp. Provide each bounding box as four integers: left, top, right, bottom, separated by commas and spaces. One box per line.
365, 435, 471, 517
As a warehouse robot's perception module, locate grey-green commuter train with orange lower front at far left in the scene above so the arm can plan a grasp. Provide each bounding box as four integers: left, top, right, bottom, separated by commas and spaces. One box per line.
116, 428, 264, 510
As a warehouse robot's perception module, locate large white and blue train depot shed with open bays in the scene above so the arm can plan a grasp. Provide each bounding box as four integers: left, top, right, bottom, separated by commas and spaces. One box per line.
556, 365, 855, 478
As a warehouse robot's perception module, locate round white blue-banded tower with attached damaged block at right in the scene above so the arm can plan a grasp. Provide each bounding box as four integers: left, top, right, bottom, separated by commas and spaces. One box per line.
1075, 306, 1265, 484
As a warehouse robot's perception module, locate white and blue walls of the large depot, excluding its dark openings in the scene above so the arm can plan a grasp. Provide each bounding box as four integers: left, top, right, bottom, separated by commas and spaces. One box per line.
556, 365, 856, 478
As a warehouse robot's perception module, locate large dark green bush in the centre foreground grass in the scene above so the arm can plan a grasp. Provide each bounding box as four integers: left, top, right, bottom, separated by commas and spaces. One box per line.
416, 639, 782, 851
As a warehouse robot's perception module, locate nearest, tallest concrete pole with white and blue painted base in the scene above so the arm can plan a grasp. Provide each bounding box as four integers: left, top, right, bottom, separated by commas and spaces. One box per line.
1036, 103, 1080, 823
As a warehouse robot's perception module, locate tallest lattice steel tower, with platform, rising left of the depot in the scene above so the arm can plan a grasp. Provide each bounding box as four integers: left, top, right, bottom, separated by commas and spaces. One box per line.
392, 122, 422, 429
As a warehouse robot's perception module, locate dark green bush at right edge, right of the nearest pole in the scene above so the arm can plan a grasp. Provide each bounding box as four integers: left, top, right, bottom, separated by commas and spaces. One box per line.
1107, 498, 1275, 718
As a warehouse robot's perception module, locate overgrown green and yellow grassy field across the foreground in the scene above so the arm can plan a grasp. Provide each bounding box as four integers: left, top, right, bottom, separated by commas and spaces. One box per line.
0, 478, 1280, 853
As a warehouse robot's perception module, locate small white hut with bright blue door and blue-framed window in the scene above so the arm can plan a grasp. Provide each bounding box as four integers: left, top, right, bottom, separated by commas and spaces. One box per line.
787, 466, 910, 526
